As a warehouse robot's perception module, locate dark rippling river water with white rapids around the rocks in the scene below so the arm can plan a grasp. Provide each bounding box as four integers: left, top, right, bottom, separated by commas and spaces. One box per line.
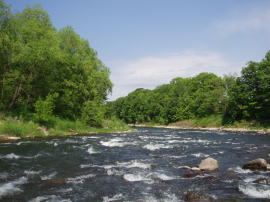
0, 128, 270, 202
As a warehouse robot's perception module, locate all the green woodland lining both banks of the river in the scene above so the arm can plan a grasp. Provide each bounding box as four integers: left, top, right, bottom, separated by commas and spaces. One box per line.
0, 0, 270, 132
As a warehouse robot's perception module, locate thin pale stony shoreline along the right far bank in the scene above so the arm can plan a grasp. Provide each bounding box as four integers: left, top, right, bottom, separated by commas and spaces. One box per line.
132, 124, 270, 135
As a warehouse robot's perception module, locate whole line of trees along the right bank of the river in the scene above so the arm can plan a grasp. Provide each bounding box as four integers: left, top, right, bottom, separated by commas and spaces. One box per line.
107, 52, 270, 125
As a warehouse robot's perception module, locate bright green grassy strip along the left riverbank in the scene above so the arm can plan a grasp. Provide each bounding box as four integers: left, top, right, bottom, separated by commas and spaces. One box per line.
0, 115, 130, 138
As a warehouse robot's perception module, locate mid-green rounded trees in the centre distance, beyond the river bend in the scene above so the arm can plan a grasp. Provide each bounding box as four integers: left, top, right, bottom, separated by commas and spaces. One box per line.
107, 73, 226, 124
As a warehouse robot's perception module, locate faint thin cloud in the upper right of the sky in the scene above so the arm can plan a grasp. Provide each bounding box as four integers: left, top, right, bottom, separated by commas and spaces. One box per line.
216, 7, 270, 36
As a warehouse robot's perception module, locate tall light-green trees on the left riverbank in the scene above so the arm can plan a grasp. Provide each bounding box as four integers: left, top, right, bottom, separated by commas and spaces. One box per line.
0, 0, 112, 126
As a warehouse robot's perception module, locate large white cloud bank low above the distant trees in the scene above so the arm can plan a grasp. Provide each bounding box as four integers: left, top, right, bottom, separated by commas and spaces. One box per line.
108, 51, 242, 100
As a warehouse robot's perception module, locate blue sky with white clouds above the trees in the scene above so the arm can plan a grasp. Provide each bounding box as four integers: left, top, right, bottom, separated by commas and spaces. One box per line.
4, 0, 270, 100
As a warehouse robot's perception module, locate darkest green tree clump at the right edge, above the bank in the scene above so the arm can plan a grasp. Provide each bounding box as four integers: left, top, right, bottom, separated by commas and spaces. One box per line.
224, 52, 270, 124
